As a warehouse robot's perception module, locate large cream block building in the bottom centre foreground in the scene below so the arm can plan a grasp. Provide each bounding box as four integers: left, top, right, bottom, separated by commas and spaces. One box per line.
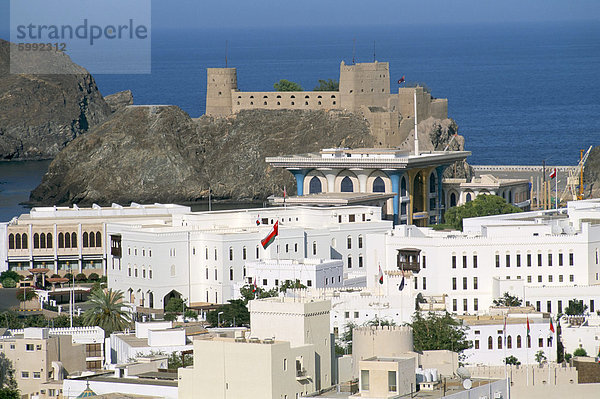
179, 298, 333, 399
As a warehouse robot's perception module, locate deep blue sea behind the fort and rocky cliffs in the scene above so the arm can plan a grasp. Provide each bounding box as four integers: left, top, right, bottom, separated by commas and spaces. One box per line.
0, 18, 600, 221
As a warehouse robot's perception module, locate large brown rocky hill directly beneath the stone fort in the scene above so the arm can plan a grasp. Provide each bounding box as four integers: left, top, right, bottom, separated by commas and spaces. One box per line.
30, 106, 373, 205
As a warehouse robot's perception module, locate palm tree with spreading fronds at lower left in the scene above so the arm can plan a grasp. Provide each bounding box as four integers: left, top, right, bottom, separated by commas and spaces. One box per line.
83, 289, 131, 336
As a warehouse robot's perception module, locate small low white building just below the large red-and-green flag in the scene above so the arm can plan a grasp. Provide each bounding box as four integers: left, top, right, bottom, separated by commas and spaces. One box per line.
245, 258, 344, 290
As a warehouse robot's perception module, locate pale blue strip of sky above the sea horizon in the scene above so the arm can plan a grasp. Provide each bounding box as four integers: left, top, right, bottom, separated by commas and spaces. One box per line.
0, 0, 600, 34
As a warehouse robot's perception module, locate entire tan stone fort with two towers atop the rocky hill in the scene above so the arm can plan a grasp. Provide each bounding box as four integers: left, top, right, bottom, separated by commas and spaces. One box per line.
206, 61, 448, 147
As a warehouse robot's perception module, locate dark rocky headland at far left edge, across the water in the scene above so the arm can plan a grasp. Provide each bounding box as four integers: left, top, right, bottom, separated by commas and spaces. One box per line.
0, 39, 111, 160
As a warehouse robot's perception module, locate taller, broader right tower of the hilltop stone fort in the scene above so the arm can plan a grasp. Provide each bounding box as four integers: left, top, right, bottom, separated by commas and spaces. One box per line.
340, 61, 390, 111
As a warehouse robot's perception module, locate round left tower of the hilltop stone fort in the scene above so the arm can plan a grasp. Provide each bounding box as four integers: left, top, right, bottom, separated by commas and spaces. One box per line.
206, 68, 237, 116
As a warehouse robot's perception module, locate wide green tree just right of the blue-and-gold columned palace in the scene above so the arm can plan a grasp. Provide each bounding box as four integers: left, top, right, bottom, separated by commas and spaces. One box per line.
444, 194, 522, 230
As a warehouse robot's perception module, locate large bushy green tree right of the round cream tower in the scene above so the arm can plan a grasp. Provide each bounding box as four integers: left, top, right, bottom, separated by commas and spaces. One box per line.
408, 311, 472, 353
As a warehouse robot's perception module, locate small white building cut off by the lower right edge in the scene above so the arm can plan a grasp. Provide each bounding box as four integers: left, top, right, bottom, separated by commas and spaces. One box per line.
560, 315, 600, 357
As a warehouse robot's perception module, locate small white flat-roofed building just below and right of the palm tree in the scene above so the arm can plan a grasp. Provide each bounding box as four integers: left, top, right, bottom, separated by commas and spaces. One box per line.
109, 321, 193, 364
